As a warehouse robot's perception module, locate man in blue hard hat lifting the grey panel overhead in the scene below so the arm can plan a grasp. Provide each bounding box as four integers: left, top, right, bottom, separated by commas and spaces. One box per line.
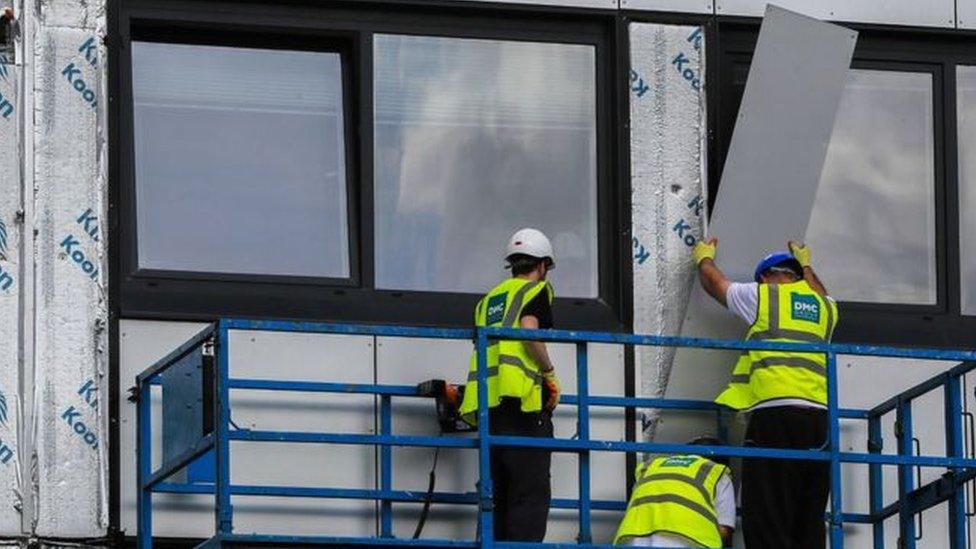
693, 238, 838, 549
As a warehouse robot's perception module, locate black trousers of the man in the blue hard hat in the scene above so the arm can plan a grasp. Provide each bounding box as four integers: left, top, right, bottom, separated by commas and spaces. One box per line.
742, 406, 830, 549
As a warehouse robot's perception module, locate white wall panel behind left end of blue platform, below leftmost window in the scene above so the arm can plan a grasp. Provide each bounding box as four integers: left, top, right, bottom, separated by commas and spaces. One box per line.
119, 320, 376, 537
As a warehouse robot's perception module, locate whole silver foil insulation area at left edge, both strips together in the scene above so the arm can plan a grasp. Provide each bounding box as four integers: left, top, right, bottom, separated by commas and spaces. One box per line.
0, 0, 108, 545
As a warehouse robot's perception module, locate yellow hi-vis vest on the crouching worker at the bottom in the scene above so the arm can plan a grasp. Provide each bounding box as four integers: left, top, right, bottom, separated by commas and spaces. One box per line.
613, 456, 728, 547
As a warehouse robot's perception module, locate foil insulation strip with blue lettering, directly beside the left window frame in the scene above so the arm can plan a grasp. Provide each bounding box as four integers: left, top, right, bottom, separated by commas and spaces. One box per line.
33, 24, 108, 538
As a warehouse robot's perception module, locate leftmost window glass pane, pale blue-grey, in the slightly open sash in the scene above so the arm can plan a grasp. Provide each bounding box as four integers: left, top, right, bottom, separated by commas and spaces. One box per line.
131, 41, 350, 278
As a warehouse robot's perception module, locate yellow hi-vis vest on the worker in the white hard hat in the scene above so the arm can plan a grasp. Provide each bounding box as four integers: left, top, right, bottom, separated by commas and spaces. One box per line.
460, 278, 554, 425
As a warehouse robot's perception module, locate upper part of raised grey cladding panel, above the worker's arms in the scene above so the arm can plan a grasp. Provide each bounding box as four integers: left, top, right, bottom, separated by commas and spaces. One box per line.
709, 6, 857, 279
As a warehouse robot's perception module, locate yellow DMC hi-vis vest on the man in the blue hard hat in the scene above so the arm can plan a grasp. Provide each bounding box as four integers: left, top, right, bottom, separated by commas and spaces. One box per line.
715, 280, 838, 410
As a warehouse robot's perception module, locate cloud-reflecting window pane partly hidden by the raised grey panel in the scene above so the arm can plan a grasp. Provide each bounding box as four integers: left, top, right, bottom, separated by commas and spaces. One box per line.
806, 69, 938, 305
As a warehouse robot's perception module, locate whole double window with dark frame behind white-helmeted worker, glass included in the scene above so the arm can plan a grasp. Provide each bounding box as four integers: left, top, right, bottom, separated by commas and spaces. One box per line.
116, 4, 616, 330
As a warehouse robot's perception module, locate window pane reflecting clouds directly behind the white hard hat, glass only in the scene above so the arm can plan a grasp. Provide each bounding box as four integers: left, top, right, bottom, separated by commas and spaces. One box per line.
374, 35, 598, 297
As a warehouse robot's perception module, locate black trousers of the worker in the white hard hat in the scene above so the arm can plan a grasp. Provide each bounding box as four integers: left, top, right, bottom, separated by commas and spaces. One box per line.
488, 398, 552, 541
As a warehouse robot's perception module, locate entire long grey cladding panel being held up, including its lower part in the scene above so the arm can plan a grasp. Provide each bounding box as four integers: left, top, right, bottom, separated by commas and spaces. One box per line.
655, 6, 857, 441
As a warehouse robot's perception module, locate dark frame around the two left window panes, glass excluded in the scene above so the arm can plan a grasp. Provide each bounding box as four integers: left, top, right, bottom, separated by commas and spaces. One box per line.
111, 0, 629, 331
